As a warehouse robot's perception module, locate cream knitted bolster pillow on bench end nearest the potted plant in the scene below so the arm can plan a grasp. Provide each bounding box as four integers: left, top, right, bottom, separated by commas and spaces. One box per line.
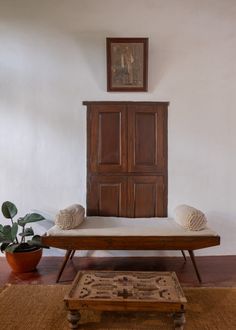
55, 204, 85, 229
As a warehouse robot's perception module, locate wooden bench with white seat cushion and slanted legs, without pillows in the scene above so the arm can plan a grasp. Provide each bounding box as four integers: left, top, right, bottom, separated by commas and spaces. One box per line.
42, 217, 220, 282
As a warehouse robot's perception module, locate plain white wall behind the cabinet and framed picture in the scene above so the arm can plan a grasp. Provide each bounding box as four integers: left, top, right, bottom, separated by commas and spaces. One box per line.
0, 0, 236, 255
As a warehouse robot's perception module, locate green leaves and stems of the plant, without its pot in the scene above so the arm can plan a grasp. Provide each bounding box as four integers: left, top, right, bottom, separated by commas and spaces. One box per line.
0, 201, 45, 252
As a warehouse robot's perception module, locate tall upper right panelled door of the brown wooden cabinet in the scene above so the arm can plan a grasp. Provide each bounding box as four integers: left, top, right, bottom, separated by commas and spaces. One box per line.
128, 105, 167, 173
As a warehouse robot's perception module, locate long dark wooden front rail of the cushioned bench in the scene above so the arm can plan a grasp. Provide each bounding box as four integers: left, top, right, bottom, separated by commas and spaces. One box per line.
42, 235, 220, 250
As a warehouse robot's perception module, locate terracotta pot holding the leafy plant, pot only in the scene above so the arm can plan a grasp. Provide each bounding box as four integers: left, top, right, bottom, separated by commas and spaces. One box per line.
6, 248, 43, 273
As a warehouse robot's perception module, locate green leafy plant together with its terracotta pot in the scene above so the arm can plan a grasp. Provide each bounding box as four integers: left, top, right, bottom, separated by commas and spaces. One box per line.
0, 201, 48, 272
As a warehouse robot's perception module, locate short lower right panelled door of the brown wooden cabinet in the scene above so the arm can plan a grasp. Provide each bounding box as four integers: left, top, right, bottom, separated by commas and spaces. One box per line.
128, 176, 167, 218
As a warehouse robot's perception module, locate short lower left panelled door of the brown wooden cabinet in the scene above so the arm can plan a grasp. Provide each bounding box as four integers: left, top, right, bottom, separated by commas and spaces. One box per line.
87, 175, 127, 217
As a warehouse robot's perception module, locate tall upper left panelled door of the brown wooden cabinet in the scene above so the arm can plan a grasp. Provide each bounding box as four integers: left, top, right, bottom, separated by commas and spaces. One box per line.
88, 104, 127, 173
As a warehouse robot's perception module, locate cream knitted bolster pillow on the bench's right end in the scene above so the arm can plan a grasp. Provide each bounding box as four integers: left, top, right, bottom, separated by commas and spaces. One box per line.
175, 205, 207, 230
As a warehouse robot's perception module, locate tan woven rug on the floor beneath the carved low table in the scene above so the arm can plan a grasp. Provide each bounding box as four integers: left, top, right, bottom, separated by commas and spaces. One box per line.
0, 285, 236, 330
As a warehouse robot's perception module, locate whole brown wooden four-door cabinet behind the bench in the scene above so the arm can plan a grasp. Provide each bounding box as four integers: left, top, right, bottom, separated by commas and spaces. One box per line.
83, 102, 168, 217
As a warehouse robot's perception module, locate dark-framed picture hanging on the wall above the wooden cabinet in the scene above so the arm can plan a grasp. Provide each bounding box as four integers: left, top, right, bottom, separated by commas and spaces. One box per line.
107, 38, 148, 92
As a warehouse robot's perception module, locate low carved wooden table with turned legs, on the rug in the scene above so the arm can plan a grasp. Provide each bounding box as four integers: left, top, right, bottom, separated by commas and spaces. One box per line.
64, 271, 187, 330
